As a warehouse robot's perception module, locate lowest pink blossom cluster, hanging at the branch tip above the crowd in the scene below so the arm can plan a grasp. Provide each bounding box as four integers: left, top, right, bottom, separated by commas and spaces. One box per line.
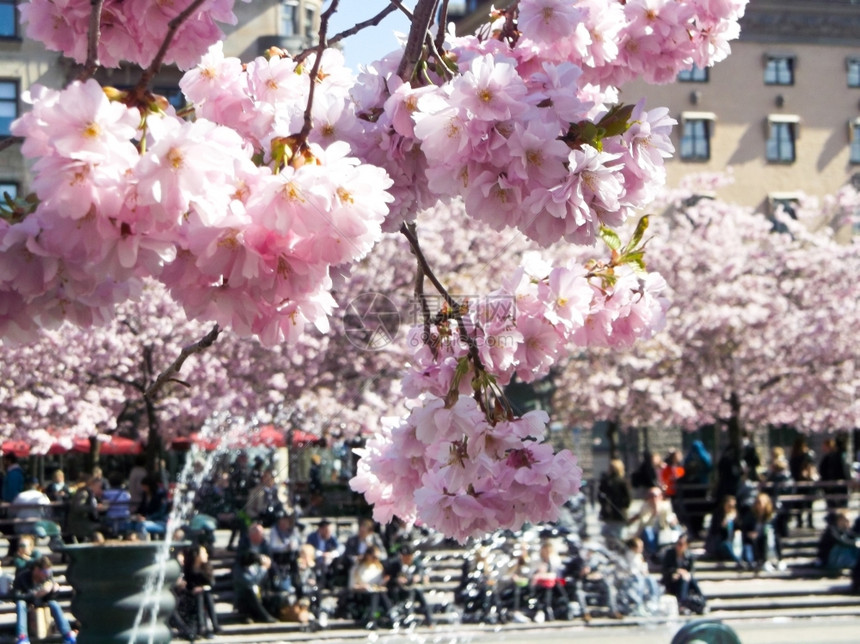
351, 396, 582, 541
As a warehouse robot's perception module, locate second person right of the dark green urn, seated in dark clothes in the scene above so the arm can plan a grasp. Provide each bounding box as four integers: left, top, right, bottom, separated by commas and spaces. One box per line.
233, 523, 278, 624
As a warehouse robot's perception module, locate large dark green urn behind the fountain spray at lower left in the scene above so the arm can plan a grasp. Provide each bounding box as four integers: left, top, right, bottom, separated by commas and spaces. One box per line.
62, 541, 185, 644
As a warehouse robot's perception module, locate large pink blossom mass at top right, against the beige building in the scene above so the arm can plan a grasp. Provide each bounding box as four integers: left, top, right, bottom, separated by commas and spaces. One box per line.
342, 0, 746, 246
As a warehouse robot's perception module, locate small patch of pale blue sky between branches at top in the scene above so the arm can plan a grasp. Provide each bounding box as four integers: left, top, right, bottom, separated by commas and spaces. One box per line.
325, 0, 415, 70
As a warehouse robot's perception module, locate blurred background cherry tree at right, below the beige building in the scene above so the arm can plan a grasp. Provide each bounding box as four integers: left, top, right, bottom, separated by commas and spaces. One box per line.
556, 177, 860, 456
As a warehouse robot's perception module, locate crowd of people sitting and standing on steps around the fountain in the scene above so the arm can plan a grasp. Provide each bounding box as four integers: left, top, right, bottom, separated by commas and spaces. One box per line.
0, 437, 860, 642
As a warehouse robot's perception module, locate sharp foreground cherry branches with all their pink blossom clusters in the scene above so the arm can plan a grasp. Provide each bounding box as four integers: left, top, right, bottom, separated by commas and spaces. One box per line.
0, 0, 745, 539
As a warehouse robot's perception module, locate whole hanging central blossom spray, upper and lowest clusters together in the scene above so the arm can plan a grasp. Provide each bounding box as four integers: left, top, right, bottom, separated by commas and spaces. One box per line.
351, 242, 667, 540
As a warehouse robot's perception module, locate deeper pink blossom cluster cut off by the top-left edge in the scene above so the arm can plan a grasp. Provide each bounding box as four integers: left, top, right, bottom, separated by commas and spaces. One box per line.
18, 0, 242, 69
